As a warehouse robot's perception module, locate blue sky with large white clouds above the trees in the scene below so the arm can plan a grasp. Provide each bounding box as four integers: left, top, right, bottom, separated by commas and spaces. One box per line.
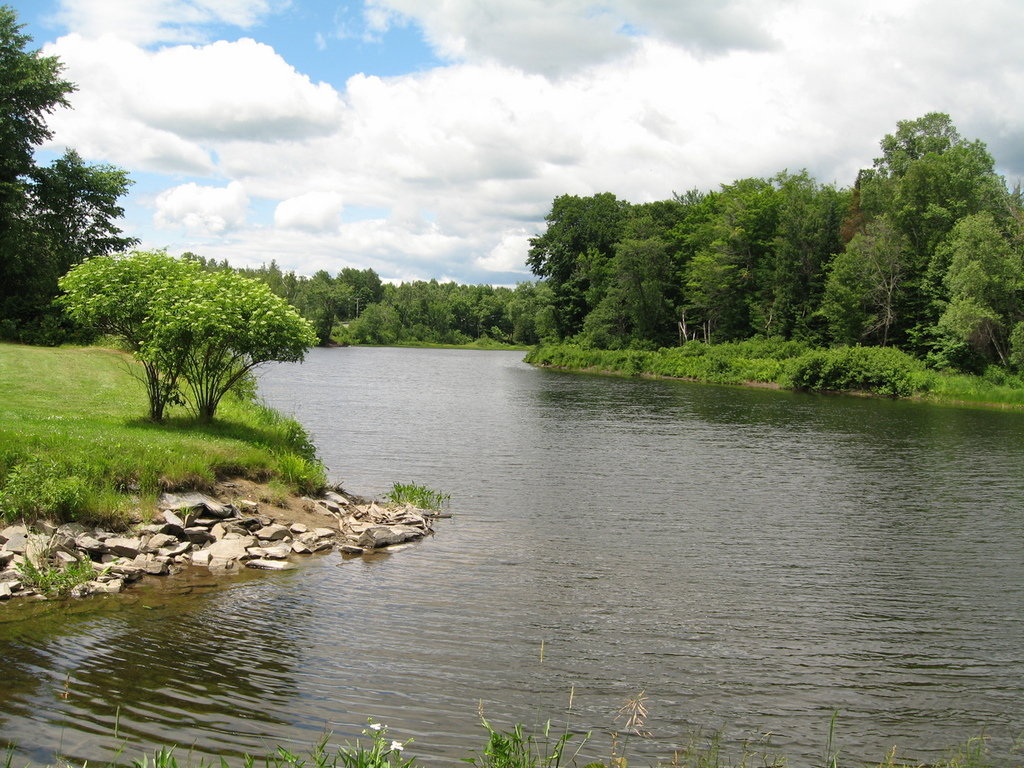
7, 0, 1024, 285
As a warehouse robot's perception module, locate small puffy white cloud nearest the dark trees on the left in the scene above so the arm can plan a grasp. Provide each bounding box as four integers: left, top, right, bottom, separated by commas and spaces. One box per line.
154, 181, 249, 234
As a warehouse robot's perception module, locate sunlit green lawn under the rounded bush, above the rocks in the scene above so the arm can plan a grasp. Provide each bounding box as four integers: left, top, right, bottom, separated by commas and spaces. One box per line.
0, 344, 324, 527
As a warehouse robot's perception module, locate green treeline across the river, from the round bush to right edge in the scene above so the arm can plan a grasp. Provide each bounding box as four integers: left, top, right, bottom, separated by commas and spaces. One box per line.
209, 113, 1024, 371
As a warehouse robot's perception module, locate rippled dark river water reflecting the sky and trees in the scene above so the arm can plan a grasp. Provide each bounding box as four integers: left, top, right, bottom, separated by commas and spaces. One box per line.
0, 348, 1024, 765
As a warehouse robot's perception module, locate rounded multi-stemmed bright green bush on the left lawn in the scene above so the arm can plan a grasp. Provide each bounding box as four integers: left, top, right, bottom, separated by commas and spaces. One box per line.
60, 251, 316, 421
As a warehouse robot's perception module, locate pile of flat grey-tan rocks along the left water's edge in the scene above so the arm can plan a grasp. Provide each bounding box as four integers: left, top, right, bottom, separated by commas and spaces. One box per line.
0, 492, 438, 600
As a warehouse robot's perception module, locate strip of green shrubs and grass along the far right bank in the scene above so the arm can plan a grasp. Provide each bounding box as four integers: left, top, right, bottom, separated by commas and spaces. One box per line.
526, 340, 1024, 408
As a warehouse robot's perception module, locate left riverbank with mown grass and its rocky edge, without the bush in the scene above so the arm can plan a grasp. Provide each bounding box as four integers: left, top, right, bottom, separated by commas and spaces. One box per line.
0, 345, 444, 600
